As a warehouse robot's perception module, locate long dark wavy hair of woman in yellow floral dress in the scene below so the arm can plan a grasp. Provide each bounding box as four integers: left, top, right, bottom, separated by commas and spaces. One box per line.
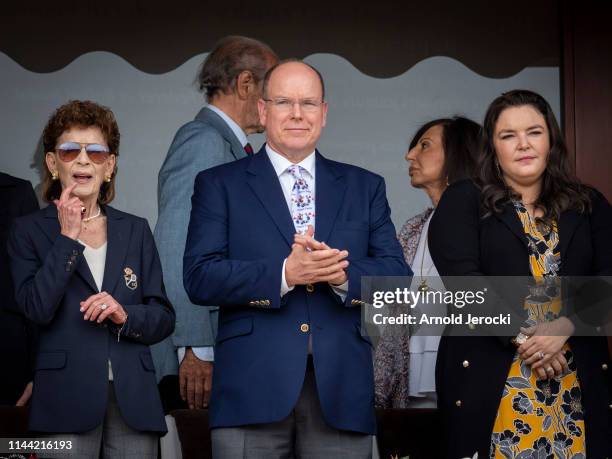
478, 89, 591, 229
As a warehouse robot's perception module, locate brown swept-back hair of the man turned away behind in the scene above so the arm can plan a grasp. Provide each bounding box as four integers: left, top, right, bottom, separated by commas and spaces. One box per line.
197, 35, 276, 101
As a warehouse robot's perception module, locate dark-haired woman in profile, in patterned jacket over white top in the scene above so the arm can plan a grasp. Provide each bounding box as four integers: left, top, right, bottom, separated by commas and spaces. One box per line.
374, 117, 481, 408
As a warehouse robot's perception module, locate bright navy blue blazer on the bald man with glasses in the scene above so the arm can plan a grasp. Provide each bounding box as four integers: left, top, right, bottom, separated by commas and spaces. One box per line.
184, 148, 410, 433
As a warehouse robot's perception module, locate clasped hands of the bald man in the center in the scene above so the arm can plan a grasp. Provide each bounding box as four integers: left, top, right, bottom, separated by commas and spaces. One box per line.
285, 225, 349, 287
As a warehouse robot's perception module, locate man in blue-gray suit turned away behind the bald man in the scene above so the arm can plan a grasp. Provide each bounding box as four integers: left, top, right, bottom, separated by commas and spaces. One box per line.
151, 36, 277, 411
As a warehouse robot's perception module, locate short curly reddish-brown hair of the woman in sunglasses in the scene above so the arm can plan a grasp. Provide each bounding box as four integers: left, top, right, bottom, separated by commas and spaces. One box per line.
42, 100, 120, 204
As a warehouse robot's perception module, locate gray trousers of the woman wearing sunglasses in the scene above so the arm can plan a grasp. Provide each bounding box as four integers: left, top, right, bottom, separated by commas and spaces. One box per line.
38, 382, 158, 459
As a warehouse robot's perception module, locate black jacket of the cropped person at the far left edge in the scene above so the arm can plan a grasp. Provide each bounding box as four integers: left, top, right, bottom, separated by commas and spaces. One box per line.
0, 172, 38, 405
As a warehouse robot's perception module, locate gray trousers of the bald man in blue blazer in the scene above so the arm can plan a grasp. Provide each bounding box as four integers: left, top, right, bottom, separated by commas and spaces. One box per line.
211, 372, 372, 459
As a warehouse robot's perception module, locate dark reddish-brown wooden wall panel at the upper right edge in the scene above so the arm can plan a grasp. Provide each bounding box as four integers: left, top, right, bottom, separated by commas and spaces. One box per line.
562, 1, 612, 201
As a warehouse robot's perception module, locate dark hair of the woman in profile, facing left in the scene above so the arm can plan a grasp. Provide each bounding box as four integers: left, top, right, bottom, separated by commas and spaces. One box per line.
409, 116, 482, 184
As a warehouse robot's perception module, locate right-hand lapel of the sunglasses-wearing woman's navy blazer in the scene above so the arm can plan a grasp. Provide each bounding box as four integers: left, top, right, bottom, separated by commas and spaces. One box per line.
102, 206, 134, 293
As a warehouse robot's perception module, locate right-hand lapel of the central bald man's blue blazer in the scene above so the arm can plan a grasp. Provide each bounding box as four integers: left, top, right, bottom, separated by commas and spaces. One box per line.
315, 151, 346, 241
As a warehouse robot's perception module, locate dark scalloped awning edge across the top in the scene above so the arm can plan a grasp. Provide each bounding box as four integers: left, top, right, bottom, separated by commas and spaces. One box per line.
0, 0, 561, 78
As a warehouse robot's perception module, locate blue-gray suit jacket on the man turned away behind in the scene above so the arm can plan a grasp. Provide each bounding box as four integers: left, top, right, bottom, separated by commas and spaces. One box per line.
151, 108, 246, 381
